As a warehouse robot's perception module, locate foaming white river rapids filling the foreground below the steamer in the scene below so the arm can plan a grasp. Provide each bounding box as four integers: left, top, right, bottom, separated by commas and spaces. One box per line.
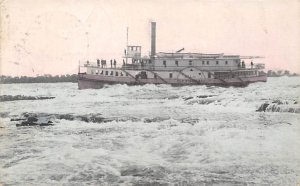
0, 77, 300, 186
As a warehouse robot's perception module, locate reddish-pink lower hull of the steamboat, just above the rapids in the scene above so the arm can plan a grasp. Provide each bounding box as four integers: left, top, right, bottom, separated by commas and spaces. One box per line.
78, 73, 267, 89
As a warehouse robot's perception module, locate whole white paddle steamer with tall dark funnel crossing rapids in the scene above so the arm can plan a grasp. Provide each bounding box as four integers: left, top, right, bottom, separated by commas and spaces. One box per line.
78, 22, 267, 89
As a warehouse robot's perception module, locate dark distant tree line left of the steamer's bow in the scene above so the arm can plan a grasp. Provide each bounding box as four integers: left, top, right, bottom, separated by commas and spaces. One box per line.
0, 74, 77, 84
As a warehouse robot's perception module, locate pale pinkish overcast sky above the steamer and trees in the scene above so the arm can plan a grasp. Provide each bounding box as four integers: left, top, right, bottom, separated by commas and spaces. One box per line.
0, 0, 300, 76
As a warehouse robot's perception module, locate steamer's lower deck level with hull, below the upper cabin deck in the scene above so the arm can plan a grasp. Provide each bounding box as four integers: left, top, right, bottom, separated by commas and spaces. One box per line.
78, 68, 267, 89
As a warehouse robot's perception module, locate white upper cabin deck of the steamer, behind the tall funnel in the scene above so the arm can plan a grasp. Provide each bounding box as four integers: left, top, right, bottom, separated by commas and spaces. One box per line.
122, 52, 258, 71
